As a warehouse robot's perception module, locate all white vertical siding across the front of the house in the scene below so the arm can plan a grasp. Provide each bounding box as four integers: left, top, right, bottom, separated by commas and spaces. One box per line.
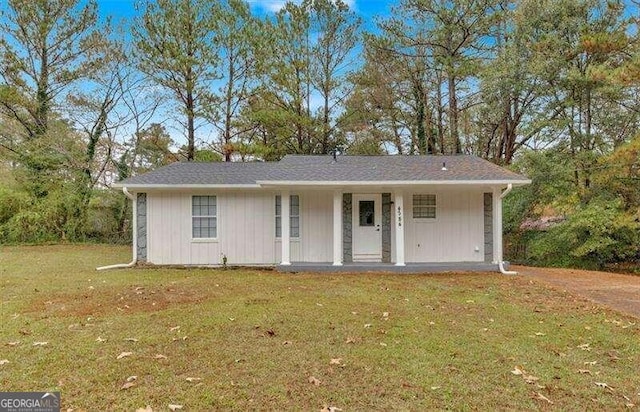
147, 189, 484, 265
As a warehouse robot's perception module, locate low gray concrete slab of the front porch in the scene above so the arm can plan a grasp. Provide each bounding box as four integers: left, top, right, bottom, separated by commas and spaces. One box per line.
276, 262, 500, 273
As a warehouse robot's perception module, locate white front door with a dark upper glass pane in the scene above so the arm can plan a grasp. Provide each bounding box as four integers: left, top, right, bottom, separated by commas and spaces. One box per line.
352, 194, 382, 262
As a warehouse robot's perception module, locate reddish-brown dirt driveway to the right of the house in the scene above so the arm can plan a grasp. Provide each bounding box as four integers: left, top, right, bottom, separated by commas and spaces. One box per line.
512, 266, 640, 318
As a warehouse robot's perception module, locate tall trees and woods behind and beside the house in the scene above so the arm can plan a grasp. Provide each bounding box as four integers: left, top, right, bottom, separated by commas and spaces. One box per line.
0, 0, 640, 266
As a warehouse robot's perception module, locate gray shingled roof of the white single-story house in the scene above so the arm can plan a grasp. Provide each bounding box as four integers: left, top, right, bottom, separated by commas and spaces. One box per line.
118, 155, 527, 186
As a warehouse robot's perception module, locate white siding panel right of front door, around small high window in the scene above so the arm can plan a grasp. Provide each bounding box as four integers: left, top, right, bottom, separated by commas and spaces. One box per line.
405, 190, 484, 262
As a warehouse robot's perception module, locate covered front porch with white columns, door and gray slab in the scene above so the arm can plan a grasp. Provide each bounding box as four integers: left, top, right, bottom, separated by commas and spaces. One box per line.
275, 185, 502, 273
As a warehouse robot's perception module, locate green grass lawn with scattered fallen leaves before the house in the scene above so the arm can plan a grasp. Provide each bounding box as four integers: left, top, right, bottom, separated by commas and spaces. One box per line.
0, 246, 640, 411
